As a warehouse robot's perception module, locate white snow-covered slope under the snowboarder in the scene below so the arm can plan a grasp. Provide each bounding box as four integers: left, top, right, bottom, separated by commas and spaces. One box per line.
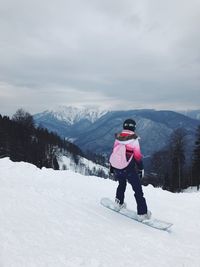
0, 158, 200, 267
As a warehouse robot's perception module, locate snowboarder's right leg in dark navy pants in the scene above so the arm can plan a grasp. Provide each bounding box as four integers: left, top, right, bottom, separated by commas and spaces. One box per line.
128, 171, 147, 215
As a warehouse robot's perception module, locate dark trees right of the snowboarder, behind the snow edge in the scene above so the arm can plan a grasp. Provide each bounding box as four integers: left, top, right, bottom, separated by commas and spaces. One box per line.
147, 126, 200, 192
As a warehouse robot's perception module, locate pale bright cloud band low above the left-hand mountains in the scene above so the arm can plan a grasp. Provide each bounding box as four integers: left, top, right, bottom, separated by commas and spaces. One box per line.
0, 83, 115, 116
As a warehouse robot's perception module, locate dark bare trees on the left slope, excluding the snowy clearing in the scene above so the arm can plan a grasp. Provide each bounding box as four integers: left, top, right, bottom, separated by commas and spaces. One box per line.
0, 109, 83, 169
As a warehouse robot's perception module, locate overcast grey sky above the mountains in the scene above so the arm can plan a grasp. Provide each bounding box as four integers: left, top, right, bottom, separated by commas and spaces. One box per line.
0, 0, 200, 115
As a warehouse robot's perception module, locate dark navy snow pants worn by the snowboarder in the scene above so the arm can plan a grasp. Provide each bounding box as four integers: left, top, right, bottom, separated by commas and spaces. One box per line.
115, 164, 147, 215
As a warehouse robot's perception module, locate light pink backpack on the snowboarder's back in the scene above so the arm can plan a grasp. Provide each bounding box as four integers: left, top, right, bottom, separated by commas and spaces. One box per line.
109, 143, 133, 170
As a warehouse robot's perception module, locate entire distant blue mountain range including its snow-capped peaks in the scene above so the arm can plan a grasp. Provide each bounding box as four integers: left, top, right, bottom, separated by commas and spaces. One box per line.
34, 108, 199, 156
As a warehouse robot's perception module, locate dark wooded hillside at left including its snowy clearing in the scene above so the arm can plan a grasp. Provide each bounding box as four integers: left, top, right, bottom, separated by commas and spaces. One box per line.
0, 113, 108, 177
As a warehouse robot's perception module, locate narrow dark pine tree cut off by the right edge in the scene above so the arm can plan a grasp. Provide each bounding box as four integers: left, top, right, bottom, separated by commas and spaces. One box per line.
192, 126, 200, 190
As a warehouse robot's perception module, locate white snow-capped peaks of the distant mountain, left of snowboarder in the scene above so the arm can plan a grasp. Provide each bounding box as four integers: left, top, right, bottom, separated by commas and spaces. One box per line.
37, 106, 108, 125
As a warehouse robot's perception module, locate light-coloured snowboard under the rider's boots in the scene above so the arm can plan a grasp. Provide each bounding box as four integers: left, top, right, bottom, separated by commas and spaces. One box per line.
100, 198, 173, 230
